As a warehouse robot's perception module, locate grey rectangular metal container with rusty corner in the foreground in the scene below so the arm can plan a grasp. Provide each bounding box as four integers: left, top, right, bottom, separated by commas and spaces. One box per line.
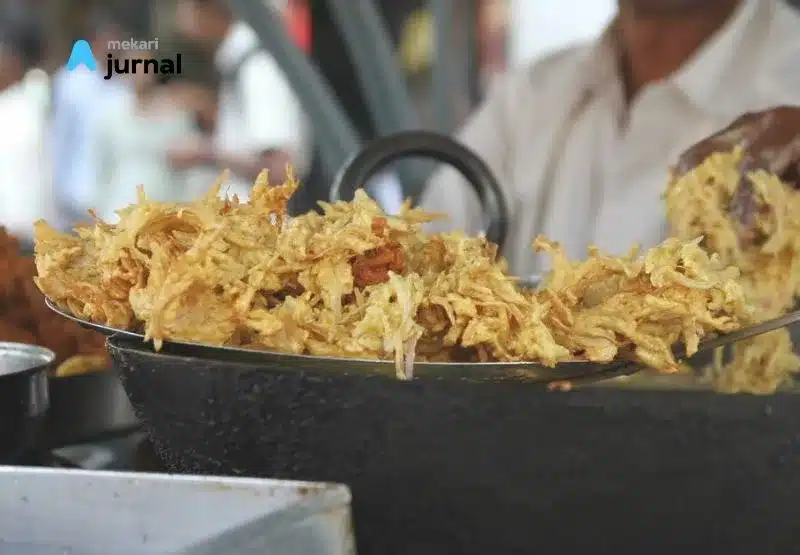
0, 467, 355, 555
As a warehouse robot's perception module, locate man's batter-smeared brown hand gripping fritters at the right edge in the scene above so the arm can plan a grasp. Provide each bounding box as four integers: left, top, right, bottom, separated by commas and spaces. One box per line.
675, 106, 800, 241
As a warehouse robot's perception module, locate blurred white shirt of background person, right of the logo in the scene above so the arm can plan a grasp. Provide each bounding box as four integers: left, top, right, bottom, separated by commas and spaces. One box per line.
214, 22, 312, 198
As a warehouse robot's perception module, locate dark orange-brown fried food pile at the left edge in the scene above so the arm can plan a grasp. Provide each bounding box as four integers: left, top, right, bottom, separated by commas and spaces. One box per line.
0, 227, 110, 377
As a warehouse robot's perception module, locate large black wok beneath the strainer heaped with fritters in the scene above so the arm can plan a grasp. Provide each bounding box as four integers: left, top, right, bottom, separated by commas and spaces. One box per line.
108, 134, 800, 555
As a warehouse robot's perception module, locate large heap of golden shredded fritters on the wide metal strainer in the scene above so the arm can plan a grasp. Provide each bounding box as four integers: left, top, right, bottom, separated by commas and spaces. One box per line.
36, 174, 752, 378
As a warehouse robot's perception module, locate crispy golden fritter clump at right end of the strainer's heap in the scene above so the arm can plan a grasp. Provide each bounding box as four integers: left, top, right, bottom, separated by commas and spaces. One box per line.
535, 237, 750, 372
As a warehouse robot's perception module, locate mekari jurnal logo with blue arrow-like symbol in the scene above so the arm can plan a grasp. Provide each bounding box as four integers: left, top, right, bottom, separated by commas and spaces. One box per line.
67, 39, 181, 80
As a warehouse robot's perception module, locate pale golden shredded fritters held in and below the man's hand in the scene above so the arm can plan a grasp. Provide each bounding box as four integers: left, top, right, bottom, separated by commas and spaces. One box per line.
665, 149, 800, 393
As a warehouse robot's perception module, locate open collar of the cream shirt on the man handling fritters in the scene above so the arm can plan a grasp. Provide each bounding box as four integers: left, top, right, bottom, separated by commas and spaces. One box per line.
580, 0, 769, 113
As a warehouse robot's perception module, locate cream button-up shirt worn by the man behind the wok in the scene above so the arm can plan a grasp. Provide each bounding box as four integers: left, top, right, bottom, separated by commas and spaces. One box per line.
421, 0, 800, 276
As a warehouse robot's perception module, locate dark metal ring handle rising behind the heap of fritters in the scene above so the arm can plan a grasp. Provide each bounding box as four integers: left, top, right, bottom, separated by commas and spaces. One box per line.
330, 131, 509, 253
